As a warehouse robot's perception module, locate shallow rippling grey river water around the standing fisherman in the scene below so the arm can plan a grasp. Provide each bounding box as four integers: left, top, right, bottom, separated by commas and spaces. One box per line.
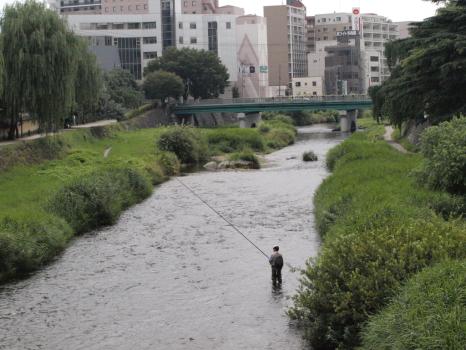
0, 126, 343, 350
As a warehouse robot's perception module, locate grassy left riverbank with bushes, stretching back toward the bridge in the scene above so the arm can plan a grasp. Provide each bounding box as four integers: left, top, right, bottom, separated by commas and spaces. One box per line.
0, 119, 294, 282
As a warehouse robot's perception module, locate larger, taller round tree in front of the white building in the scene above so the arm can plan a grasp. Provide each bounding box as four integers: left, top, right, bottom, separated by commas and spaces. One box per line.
144, 48, 229, 99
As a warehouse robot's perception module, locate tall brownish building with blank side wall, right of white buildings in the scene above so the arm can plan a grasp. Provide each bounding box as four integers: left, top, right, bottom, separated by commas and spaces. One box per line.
264, 0, 308, 94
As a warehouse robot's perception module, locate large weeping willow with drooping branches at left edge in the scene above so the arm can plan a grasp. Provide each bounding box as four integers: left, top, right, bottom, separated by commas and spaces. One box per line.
1, 0, 79, 138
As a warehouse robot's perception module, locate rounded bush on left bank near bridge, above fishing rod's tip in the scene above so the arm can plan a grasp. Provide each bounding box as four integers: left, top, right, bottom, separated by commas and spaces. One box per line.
157, 126, 208, 164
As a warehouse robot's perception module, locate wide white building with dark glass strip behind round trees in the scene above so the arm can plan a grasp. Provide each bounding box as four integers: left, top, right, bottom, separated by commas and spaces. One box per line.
59, 0, 268, 97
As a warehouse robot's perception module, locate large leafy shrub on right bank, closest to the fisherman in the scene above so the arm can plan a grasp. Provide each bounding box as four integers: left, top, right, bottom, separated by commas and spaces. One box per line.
290, 218, 466, 349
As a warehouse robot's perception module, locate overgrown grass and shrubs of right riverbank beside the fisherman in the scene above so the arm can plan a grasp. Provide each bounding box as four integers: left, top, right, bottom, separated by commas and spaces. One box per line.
290, 122, 466, 349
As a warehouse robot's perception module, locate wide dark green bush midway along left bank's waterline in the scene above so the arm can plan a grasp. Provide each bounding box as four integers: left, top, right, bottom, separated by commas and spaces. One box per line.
48, 168, 152, 234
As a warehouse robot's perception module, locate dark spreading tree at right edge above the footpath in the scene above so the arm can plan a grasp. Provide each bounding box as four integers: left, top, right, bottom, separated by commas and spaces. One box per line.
373, 0, 466, 125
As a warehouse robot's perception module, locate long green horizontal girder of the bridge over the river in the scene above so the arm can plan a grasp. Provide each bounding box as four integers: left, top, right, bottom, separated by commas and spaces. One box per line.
174, 95, 372, 116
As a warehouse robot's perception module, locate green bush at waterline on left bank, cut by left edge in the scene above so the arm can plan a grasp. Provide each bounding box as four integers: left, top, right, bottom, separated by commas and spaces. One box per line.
0, 213, 73, 282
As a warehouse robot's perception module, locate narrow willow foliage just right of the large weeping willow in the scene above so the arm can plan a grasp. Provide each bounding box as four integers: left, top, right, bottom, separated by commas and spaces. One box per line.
74, 39, 103, 116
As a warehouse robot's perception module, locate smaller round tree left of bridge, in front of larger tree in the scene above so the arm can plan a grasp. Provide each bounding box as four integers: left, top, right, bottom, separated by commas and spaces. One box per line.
143, 71, 184, 103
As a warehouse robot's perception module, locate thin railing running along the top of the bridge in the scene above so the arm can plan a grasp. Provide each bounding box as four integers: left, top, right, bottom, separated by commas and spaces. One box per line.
180, 95, 371, 106
